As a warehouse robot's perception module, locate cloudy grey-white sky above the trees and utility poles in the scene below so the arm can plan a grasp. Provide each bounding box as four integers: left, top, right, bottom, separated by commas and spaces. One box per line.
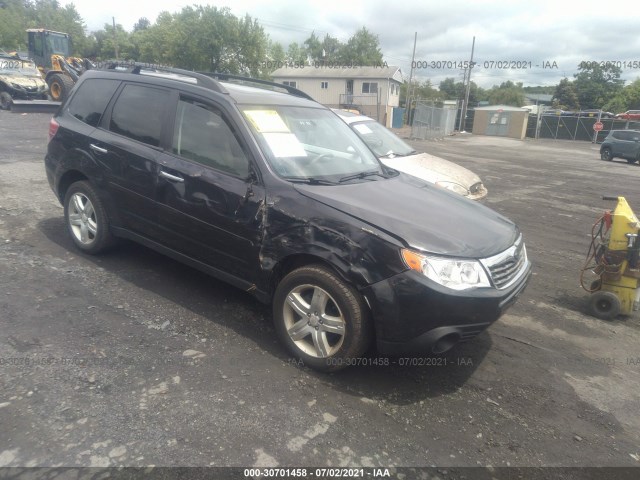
69, 0, 640, 88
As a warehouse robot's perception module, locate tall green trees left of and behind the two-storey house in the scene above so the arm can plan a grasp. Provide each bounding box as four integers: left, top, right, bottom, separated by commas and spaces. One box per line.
0, 0, 382, 77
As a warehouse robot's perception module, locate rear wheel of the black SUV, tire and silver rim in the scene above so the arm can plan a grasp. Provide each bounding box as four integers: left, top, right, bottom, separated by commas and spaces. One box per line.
64, 181, 114, 255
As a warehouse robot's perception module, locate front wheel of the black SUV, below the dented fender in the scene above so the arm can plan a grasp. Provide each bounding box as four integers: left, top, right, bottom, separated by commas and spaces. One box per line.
273, 265, 372, 372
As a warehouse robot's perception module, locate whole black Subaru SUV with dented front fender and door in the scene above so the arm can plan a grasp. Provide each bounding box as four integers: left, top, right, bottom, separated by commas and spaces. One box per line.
45, 65, 531, 371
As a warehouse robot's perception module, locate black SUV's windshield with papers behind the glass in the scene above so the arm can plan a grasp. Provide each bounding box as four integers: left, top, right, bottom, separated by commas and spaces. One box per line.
242, 106, 384, 183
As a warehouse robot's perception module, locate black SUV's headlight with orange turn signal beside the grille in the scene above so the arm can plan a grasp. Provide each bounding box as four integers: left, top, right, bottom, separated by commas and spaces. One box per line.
402, 249, 491, 290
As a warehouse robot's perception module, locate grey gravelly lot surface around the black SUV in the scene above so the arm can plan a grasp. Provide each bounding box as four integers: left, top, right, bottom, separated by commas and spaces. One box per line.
0, 112, 640, 468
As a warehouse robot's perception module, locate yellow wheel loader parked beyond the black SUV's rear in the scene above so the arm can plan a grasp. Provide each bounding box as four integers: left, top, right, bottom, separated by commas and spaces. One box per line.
27, 28, 93, 102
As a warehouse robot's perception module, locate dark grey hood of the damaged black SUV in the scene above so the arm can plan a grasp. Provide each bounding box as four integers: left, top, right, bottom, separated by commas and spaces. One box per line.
295, 174, 519, 258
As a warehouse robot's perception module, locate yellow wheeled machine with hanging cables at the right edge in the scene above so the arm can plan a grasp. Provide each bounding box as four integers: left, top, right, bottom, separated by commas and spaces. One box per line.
580, 197, 640, 320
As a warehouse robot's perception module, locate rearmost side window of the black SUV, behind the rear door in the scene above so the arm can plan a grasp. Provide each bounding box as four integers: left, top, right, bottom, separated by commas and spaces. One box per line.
69, 78, 120, 127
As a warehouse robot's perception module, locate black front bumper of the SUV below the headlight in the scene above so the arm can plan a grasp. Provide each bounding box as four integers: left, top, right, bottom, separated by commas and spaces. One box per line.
363, 262, 531, 355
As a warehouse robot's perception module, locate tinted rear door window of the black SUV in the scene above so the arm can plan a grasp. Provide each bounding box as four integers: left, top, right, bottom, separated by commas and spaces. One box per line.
109, 85, 168, 147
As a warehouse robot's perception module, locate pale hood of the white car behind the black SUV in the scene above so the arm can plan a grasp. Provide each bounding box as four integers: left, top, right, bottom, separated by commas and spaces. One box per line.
380, 153, 482, 194
